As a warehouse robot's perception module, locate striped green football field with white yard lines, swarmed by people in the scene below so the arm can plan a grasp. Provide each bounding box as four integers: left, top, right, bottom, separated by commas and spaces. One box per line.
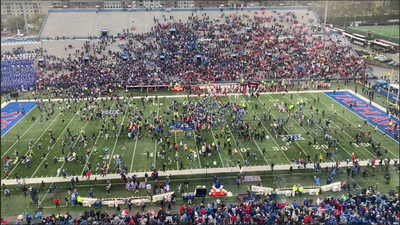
1, 91, 399, 179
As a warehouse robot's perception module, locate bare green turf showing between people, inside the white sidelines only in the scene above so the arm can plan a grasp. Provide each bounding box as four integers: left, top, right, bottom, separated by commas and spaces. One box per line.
1, 90, 399, 179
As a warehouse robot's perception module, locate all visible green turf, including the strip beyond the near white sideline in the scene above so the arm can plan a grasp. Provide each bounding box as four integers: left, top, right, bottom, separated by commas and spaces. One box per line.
1, 88, 399, 216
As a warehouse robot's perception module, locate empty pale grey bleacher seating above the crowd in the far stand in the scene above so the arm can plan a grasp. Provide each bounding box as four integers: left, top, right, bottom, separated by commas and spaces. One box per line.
40, 7, 322, 38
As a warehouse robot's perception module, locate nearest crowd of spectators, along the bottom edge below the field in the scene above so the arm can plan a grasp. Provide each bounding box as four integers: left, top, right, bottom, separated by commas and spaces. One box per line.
5, 186, 400, 225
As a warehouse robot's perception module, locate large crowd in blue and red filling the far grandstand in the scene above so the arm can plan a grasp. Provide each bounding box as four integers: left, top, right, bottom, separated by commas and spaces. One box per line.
29, 8, 368, 95
